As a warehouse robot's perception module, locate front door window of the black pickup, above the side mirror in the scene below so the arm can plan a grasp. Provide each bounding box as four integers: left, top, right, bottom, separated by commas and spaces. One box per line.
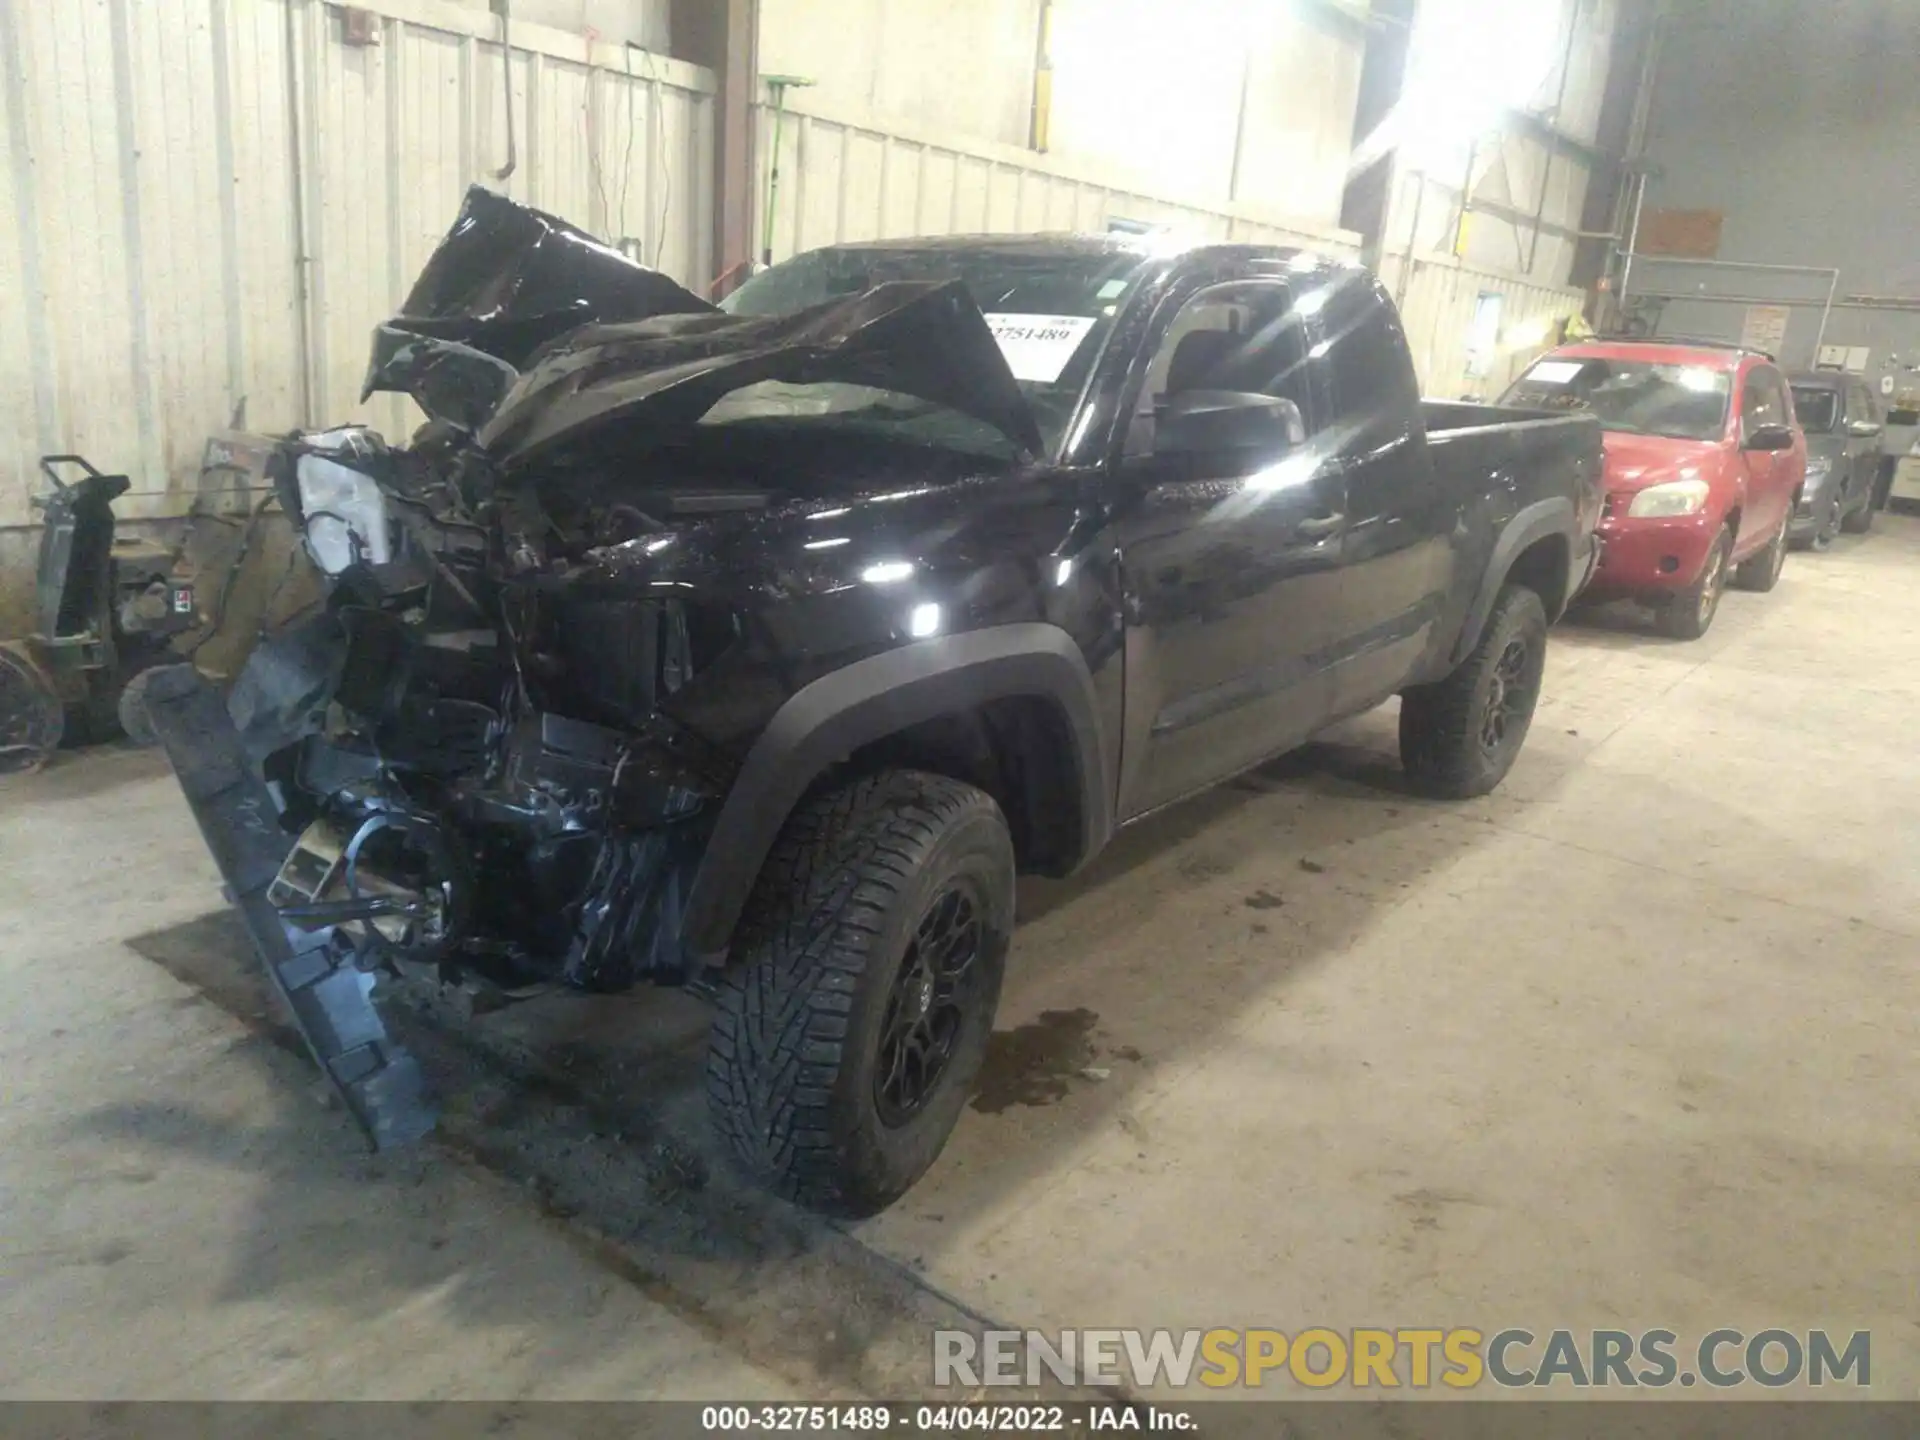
1127, 280, 1315, 455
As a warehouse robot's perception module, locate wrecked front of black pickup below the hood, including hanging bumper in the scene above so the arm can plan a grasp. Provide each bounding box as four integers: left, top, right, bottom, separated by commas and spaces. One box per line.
146, 428, 730, 1146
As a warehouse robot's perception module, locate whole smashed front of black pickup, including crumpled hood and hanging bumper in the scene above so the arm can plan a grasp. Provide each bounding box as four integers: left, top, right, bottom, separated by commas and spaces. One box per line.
148, 190, 1041, 1146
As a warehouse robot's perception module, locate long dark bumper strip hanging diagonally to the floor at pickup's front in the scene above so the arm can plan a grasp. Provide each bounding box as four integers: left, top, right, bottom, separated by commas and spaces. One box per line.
144, 664, 436, 1150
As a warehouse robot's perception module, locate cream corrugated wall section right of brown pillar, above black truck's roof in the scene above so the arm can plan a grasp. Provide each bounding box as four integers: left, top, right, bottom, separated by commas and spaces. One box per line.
755, 90, 1359, 270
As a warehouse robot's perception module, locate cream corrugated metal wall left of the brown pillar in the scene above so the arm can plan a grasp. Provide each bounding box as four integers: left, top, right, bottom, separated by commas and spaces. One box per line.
0, 0, 712, 524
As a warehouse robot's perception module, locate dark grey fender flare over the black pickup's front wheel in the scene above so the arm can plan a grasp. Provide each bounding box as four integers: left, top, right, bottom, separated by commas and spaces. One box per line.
682, 622, 1114, 964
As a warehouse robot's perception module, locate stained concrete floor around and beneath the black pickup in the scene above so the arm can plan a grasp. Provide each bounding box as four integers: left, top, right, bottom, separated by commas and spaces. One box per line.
0, 516, 1920, 1398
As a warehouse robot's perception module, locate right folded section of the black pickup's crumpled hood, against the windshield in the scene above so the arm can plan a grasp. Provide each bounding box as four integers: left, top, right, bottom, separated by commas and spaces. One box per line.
480, 280, 1041, 461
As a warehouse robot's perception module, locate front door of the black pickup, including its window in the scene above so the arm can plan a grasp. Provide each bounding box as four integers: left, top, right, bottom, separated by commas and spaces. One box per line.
1110, 278, 1346, 820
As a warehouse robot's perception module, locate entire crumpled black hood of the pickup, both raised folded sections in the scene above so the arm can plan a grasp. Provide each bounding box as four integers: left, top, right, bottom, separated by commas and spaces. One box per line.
365, 186, 1041, 467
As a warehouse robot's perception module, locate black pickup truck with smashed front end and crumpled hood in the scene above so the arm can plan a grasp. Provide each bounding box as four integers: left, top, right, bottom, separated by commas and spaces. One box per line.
146, 190, 1601, 1213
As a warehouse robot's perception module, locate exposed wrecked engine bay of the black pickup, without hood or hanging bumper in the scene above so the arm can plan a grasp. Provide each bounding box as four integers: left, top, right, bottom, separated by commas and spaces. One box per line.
228, 432, 730, 993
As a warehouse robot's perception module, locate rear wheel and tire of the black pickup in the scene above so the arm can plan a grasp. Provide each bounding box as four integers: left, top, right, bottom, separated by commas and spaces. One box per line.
1400, 586, 1548, 801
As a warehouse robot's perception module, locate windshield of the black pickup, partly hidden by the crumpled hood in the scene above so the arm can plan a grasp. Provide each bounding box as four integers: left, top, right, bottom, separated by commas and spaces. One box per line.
707, 246, 1140, 453
